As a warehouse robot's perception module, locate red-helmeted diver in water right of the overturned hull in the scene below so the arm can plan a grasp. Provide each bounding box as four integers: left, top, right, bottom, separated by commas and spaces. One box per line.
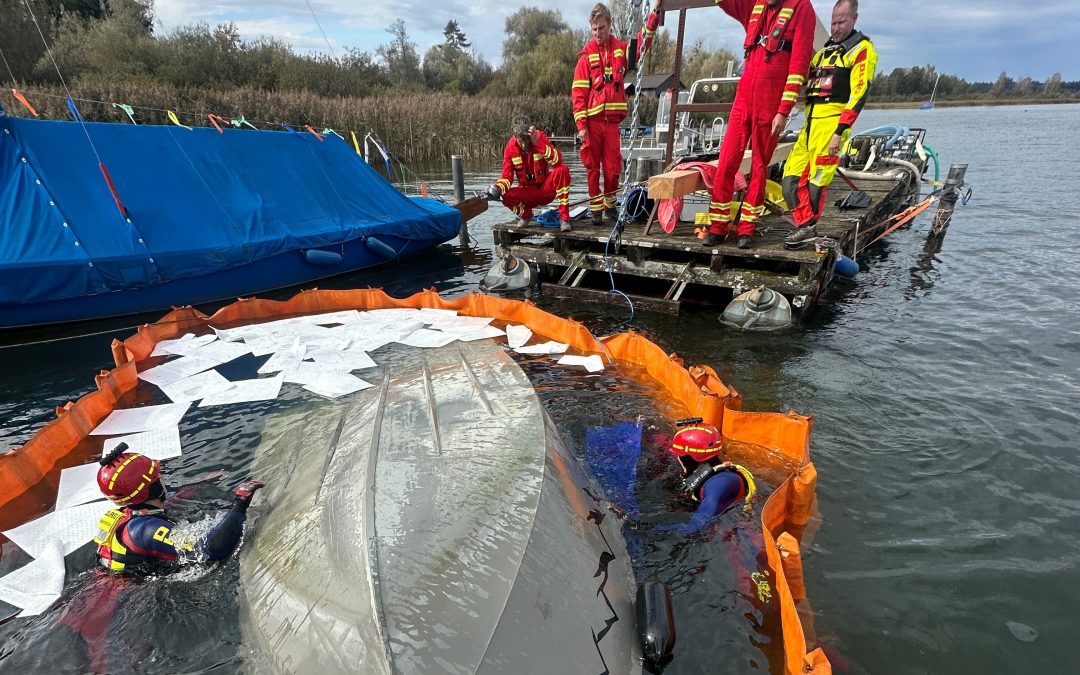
665, 417, 757, 532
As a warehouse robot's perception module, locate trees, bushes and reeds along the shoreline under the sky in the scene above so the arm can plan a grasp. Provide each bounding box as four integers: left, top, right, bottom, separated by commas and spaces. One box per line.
0, 0, 1080, 159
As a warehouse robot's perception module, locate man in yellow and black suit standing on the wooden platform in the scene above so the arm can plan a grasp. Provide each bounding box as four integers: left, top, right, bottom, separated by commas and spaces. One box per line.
782, 0, 877, 248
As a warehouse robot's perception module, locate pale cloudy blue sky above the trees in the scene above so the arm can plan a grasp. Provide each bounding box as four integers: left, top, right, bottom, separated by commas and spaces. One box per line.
154, 0, 1080, 81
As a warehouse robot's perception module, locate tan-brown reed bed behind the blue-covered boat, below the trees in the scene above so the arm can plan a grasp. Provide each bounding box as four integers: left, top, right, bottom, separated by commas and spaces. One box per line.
0, 79, 575, 162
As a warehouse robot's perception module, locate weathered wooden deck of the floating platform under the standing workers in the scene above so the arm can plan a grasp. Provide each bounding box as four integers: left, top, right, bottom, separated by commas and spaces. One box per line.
492, 162, 919, 313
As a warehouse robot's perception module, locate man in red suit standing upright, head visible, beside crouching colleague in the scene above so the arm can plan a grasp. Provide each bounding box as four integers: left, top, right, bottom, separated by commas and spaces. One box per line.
570, 2, 626, 225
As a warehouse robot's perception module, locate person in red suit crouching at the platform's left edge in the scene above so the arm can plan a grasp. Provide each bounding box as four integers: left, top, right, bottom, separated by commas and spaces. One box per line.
487, 114, 570, 232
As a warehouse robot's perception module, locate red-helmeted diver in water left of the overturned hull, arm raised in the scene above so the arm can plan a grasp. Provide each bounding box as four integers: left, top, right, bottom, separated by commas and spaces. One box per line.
94, 443, 262, 575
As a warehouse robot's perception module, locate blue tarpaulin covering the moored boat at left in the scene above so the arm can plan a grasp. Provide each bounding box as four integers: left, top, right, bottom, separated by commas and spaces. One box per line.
0, 116, 460, 305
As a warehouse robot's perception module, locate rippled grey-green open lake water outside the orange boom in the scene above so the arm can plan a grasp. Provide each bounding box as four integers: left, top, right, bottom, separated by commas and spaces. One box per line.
0, 106, 1080, 674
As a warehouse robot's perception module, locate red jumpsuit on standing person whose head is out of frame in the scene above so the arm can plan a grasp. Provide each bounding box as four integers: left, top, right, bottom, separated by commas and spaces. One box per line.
708, 0, 816, 235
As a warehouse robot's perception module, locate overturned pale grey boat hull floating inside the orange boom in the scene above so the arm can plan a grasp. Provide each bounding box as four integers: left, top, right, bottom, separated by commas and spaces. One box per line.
241, 340, 640, 674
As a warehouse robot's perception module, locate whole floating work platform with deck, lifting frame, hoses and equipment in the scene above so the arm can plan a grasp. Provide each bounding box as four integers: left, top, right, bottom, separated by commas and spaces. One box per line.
492, 0, 967, 313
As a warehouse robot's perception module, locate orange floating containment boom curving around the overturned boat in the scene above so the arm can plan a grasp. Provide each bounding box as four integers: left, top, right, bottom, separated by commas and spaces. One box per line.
0, 288, 832, 675
